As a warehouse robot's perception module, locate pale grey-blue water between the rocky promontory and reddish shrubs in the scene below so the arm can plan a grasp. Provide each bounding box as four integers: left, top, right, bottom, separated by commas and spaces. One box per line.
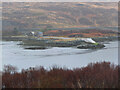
0, 41, 118, 70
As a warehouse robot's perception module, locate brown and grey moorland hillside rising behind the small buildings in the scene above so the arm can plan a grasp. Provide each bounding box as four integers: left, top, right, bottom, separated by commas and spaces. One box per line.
2, 2, 118, 30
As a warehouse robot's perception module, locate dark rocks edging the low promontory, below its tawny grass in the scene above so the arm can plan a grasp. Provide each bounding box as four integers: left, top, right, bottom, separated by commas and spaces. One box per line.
21, 39, 105, 50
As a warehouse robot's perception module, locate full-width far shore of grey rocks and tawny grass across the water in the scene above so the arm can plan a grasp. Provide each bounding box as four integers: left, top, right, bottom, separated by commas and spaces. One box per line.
2, 36, 118, 50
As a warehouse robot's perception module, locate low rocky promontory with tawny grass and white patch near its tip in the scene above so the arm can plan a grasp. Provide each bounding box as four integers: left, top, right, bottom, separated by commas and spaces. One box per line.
21, 37, 105, 50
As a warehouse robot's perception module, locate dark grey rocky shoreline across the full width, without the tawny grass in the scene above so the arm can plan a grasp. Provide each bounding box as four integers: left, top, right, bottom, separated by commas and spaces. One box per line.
3, 37, 118, 50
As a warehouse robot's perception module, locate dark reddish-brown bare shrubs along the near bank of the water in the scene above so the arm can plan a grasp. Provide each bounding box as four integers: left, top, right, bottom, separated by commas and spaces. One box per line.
2, 62, 119, 88
